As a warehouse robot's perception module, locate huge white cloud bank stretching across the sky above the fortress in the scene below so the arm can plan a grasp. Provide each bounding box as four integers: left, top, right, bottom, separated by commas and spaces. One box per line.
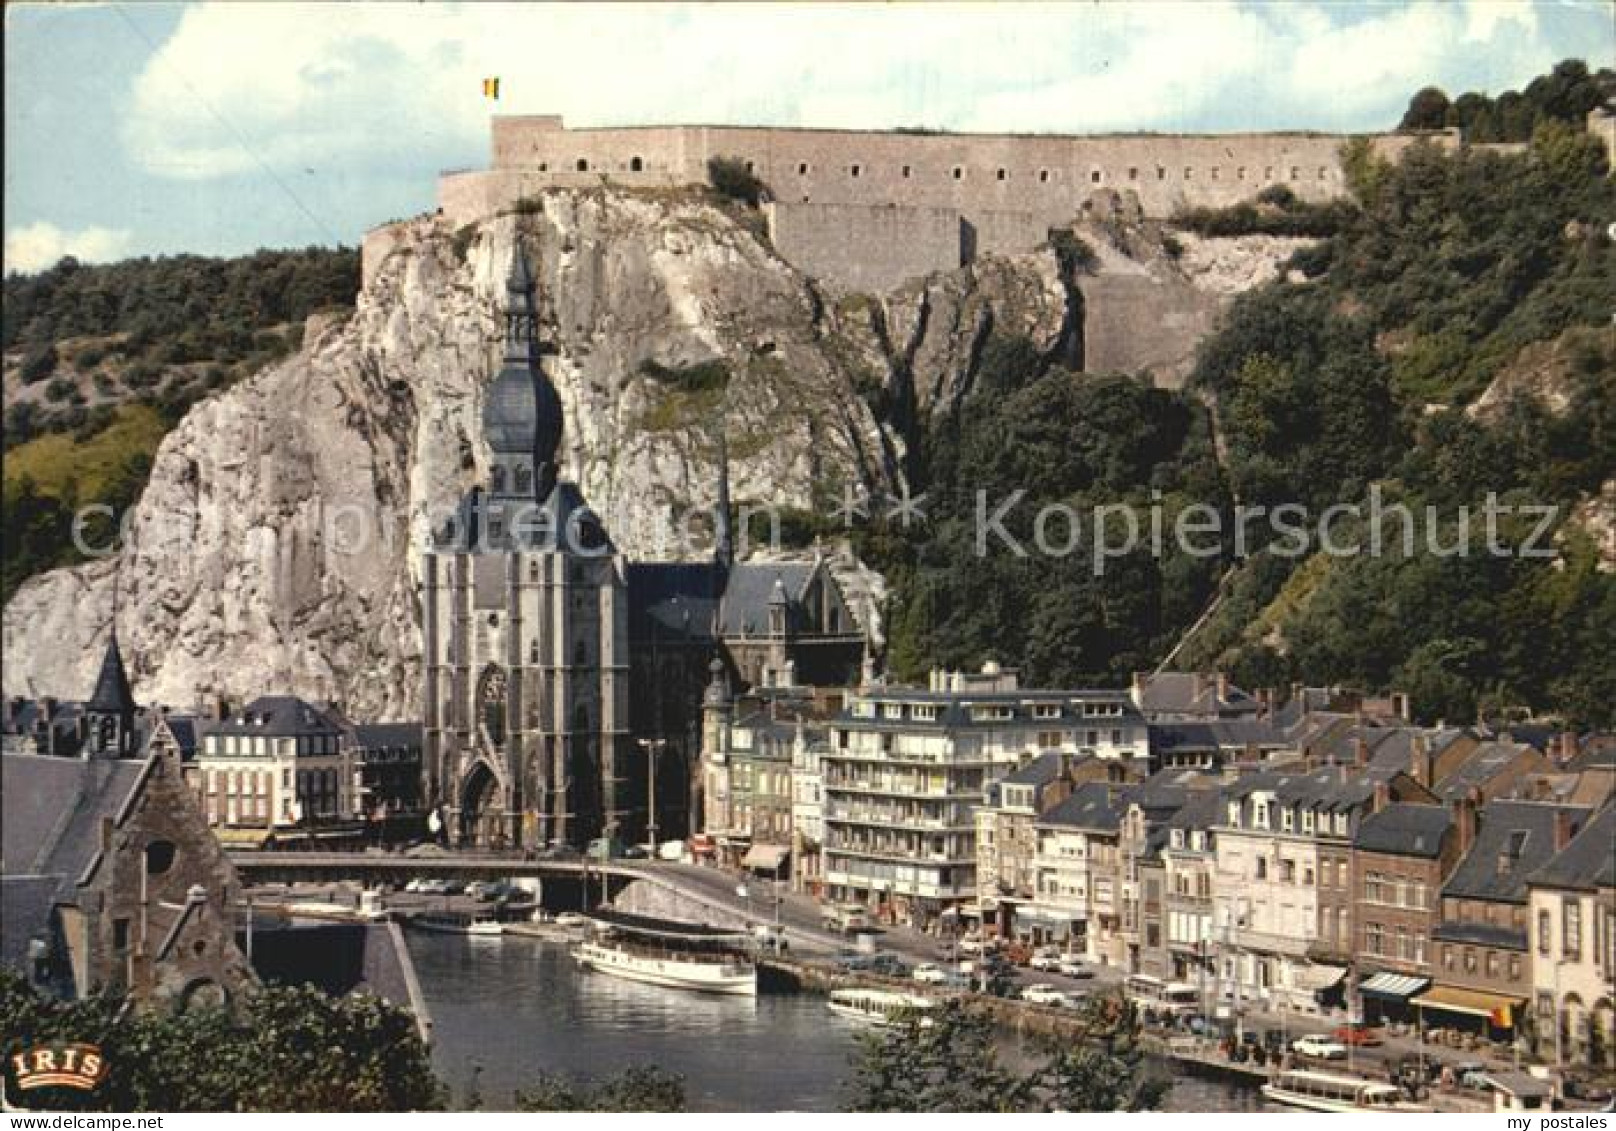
123, 0, 1596, 179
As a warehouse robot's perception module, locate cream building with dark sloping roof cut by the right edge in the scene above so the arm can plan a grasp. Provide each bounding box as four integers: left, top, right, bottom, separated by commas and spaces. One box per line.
1527, 808, 1616, 1070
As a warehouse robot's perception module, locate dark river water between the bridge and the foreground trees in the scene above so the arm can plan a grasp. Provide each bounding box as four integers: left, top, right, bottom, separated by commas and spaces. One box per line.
407, 931, 1264, 1112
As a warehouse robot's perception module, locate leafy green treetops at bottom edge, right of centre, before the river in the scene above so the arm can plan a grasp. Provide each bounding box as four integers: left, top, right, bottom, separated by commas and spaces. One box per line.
847, 997, 1168, 1113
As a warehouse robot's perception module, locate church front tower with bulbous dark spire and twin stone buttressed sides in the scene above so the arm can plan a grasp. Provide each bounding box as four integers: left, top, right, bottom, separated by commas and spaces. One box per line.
422, 249, 629, 847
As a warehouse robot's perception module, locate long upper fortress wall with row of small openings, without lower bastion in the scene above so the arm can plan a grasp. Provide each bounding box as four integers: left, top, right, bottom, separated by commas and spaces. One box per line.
493, 116, 1456, 218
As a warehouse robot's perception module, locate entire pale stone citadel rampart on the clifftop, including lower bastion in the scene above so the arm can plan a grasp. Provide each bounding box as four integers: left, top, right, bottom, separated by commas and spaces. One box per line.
387, 115, 1458, 291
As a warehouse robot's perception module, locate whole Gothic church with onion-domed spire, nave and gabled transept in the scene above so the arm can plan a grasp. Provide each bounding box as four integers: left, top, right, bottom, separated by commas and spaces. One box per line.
422, 250, 866, 848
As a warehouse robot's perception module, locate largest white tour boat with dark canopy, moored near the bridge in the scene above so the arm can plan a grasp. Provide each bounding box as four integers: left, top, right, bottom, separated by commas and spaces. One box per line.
572, 910, 758, 997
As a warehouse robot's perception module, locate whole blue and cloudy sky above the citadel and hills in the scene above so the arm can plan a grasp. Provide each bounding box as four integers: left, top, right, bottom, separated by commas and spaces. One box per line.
5, 0, 1616, 271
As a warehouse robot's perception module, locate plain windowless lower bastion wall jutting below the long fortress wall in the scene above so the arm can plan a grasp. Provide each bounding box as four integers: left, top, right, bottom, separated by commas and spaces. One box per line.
768, 202, 962, 292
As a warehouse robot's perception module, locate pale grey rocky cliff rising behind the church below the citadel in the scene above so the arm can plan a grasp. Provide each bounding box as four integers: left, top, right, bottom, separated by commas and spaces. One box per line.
5, 191, 1286, 717
